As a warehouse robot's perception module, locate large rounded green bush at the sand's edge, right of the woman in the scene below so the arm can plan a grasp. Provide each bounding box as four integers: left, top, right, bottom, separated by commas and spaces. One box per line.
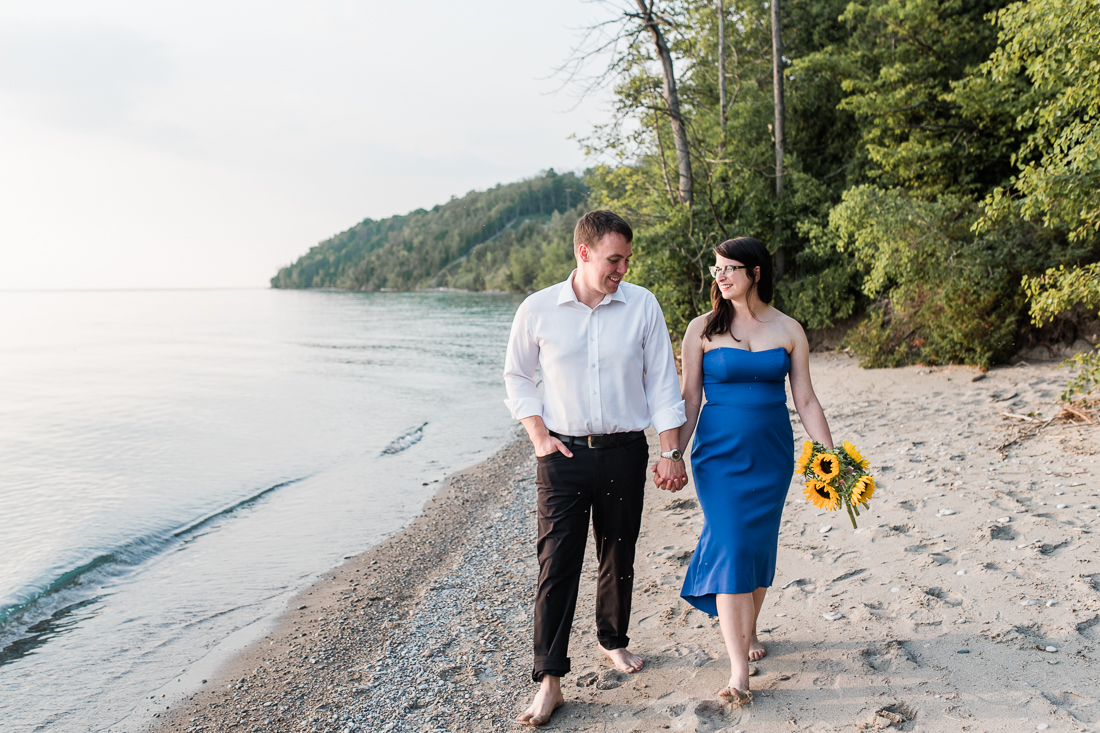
829, 185, 1034, 367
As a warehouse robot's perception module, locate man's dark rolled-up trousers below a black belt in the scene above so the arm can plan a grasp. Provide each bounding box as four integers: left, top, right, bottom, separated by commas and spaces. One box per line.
532, 436, 649, 681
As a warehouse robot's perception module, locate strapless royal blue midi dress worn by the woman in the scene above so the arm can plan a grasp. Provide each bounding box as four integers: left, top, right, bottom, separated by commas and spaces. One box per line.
680, 348, 794, 615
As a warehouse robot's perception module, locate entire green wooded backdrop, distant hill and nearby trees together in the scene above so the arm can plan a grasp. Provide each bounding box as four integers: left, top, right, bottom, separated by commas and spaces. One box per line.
273, 0, 1100, 384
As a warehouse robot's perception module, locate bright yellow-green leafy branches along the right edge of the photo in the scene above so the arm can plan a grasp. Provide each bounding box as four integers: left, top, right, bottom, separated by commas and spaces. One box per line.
976, 0, 1100, 400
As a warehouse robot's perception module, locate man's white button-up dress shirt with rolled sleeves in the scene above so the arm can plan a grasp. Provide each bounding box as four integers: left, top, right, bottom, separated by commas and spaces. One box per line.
504, 270, 686, 436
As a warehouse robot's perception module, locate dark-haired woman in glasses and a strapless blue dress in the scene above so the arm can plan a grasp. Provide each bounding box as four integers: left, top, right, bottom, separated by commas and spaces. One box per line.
680, 237, 833, 704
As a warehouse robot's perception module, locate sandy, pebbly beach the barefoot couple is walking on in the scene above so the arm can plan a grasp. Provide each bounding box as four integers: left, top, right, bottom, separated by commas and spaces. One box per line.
157, 353, 1100, 733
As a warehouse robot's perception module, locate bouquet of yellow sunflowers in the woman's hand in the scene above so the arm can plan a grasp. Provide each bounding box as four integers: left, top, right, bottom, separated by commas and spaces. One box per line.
794, 440, 875, 527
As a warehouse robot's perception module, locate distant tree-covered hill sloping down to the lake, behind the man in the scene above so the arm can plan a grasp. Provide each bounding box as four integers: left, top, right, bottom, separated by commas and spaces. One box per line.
272, 169, 589, 291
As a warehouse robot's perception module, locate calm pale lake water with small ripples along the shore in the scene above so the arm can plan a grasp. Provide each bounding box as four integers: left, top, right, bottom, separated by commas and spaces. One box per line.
0, 289, 520, 731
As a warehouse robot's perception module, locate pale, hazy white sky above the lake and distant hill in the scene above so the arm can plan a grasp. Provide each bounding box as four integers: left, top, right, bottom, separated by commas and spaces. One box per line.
0, 0, 606, 289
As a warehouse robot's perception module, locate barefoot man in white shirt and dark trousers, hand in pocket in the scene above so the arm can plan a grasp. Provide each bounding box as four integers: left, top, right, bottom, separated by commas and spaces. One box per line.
504, 210, 688, 725
